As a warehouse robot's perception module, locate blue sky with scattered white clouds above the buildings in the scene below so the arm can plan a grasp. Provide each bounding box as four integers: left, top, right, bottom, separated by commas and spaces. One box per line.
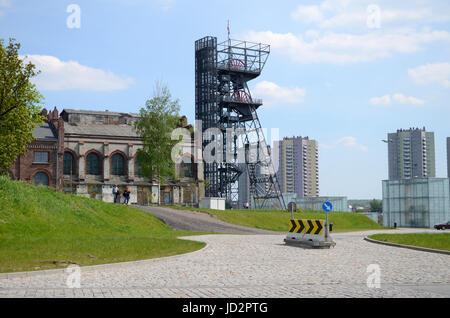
0, 0, 450, 199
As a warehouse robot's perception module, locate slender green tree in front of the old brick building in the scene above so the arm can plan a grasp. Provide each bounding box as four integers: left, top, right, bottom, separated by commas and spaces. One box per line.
135, 83, 180, 183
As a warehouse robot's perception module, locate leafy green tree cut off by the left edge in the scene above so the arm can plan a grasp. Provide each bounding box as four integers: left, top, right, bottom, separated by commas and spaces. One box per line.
0, 39, 44, 173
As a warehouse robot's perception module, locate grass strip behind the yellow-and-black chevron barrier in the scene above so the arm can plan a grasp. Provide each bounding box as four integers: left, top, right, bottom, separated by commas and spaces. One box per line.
167, 206, 383, 233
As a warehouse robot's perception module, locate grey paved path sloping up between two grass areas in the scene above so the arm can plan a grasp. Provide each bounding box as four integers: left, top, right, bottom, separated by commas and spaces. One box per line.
138, 206, 280, 235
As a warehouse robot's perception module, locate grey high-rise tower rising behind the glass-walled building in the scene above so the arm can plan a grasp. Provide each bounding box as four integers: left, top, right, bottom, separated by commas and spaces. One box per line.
388, 127, 436, 180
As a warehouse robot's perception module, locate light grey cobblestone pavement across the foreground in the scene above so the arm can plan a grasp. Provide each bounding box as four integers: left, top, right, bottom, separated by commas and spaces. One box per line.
0, 229, 450, 298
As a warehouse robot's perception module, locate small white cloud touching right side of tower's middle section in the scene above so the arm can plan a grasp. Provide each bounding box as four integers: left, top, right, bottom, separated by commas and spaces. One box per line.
252, 81, 306, 105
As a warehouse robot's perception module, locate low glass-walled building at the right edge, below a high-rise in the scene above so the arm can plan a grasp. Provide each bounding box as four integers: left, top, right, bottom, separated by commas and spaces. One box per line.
383, 178, 450, 228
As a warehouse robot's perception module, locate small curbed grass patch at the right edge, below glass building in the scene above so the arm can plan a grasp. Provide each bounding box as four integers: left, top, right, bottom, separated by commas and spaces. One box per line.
369, 233, 450, 251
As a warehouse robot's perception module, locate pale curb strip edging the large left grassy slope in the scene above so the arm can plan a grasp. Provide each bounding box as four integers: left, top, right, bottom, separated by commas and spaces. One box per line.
0, 236, 210, 279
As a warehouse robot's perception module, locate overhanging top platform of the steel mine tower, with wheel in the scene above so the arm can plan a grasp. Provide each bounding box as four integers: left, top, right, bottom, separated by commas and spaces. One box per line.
217, 39, 270, 75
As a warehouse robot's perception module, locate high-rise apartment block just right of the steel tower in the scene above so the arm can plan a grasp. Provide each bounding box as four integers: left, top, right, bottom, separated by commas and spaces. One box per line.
275, 137, 319, 198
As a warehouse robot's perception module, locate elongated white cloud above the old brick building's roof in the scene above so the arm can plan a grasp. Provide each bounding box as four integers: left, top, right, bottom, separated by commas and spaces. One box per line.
24, 55, 134, 91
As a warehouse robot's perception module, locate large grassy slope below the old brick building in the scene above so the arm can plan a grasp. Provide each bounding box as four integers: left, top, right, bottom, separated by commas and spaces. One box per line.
0, 177, 205, 272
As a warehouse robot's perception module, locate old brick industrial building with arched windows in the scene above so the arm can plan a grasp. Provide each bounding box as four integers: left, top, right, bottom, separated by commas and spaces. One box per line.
9, 108, 203, 205
